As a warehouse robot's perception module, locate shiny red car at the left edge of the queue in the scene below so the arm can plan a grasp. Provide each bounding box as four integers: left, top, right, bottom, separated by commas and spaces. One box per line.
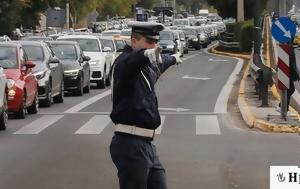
0, 42, 39, 118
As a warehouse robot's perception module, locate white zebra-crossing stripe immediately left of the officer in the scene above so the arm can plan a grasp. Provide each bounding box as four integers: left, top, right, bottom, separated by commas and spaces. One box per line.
75, 115, 111, 134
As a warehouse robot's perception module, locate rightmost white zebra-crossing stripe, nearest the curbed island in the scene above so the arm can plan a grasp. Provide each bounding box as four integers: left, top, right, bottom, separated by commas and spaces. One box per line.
196, 115, 221, 135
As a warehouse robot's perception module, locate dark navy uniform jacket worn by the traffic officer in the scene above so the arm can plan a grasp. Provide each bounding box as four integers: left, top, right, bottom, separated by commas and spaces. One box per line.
110, 46, 176, 129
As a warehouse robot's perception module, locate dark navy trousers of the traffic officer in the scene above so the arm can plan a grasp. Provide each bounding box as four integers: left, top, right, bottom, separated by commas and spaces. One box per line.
110, 134, 167, 189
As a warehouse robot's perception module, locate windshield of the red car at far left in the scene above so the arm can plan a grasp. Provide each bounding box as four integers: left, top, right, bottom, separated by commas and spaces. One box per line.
0, 47, 17, 68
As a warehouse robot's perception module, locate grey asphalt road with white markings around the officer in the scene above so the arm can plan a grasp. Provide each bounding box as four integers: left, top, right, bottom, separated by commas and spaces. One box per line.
0, 44, 300, 189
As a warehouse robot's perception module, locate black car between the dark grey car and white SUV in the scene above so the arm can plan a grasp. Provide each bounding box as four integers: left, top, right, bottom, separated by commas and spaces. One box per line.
48, 41, 91, 96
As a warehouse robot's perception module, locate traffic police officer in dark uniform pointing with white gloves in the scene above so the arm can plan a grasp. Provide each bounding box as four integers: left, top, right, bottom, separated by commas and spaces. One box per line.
110, 22, 181, 189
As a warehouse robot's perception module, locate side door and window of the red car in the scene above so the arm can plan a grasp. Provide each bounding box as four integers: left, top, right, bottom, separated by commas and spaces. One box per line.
19, 47, 37, 106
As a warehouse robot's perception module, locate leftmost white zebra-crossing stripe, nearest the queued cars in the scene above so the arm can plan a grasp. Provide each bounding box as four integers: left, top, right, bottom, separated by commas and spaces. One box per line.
14, 115, 64, 134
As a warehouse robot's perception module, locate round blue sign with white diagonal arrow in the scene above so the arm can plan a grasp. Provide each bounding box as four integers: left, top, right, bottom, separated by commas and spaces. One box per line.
271, 17, 296, 43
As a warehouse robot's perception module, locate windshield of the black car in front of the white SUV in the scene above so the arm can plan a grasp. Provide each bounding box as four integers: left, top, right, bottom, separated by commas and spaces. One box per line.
51, 44, 77, 60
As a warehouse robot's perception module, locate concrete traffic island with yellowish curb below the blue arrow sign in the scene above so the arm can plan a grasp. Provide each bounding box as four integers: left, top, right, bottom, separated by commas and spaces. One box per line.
211, 48, 300, 133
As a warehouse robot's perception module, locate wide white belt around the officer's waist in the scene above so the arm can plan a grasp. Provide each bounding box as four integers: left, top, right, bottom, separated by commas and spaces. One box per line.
115, 124, 155, 138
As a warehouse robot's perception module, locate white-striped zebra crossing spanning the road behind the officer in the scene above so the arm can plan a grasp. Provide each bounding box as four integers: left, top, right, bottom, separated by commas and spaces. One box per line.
9, 115, 222, 135
